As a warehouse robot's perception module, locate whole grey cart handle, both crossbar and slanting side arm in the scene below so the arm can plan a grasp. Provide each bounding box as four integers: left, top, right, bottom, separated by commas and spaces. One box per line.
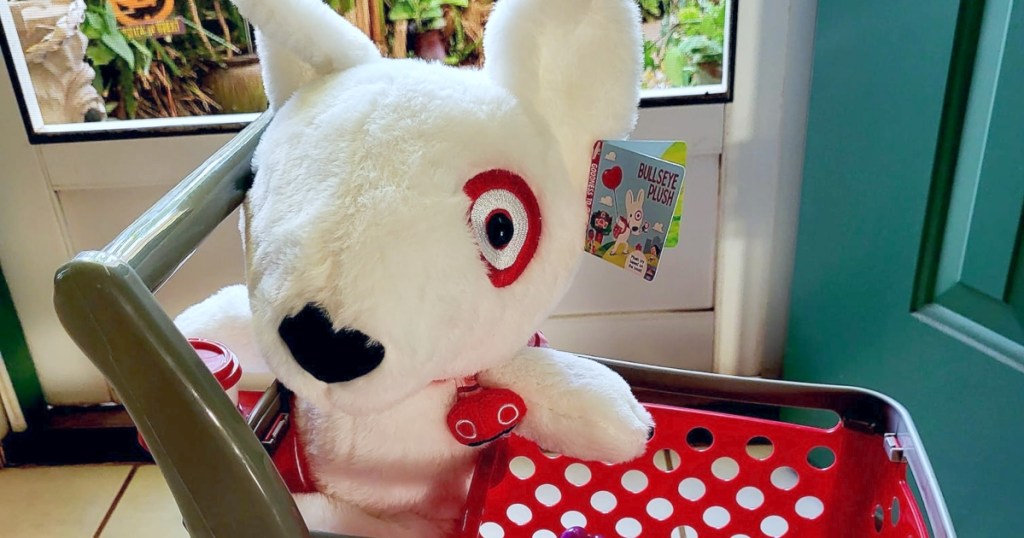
48, 114, 309, 538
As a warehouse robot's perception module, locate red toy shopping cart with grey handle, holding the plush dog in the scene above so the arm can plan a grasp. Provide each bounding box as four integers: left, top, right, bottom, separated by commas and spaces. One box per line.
54, 115, 954, 538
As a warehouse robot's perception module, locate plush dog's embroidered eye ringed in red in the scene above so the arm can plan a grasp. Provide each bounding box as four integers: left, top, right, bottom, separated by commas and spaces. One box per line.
463, 170, 541, 288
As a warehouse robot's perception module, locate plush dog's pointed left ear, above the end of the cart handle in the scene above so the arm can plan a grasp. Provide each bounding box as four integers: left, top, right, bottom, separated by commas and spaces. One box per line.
234, 0, 381, 110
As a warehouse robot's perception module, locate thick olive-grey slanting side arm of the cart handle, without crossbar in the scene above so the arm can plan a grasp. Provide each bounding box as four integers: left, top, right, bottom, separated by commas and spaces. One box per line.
54, 252, 309, 538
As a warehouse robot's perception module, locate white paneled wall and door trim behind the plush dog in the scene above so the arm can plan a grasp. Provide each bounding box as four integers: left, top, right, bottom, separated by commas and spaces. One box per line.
0, 0, 815, 405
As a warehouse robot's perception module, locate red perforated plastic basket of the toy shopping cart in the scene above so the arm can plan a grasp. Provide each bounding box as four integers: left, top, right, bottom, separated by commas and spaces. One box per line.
461, 405, 928, 538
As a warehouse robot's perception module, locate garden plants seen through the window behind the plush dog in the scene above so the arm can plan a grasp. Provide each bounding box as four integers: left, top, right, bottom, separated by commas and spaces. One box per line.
6, 0, 730, 127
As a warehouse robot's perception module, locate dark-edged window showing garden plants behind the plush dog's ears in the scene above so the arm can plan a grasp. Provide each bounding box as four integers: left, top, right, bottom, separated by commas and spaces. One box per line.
0, 0, 735, 142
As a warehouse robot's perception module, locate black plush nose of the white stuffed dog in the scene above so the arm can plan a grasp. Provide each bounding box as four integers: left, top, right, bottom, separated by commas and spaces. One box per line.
278, 303, 384, 383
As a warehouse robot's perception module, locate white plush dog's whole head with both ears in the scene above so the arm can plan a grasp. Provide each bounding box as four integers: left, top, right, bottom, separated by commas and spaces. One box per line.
236, 0, 642, 414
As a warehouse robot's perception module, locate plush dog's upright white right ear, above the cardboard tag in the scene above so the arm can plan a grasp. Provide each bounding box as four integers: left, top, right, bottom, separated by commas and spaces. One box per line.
483, 0, 643, 182
